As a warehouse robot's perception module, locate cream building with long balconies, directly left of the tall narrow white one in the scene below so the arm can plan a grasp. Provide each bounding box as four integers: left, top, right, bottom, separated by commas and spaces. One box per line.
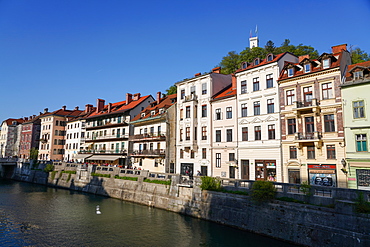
130, 92, 177, 173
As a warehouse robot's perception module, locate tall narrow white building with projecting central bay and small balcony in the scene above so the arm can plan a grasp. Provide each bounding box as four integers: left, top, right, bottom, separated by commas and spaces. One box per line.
175, 67, 231, 176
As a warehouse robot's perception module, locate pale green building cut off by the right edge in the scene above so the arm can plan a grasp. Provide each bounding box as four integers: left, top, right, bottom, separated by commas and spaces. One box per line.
341, 61, 370, 190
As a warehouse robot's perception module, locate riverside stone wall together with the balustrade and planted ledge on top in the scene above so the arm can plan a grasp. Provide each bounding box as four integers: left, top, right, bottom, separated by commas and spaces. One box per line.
4, 162, 370, 246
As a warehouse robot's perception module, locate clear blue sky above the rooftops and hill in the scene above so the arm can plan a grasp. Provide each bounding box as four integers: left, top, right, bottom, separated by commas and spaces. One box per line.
0, 0, 370, 121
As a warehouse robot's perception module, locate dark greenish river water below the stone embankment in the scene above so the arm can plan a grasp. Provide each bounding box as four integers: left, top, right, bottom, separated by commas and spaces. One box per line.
0, 179, 295, 247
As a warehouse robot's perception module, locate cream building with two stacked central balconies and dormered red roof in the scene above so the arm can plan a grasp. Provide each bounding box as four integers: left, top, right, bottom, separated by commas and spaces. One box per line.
279, 45, 351, 187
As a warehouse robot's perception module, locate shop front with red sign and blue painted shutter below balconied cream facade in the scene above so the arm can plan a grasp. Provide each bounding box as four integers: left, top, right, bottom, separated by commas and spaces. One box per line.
308, 164, 337, 187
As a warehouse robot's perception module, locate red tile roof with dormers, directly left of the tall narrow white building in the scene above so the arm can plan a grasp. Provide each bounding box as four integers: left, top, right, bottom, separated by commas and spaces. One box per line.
131, 94, 177, 122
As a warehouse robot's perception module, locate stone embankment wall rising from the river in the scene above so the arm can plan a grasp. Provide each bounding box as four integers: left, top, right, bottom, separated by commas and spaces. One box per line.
10, 162, 370, 246
